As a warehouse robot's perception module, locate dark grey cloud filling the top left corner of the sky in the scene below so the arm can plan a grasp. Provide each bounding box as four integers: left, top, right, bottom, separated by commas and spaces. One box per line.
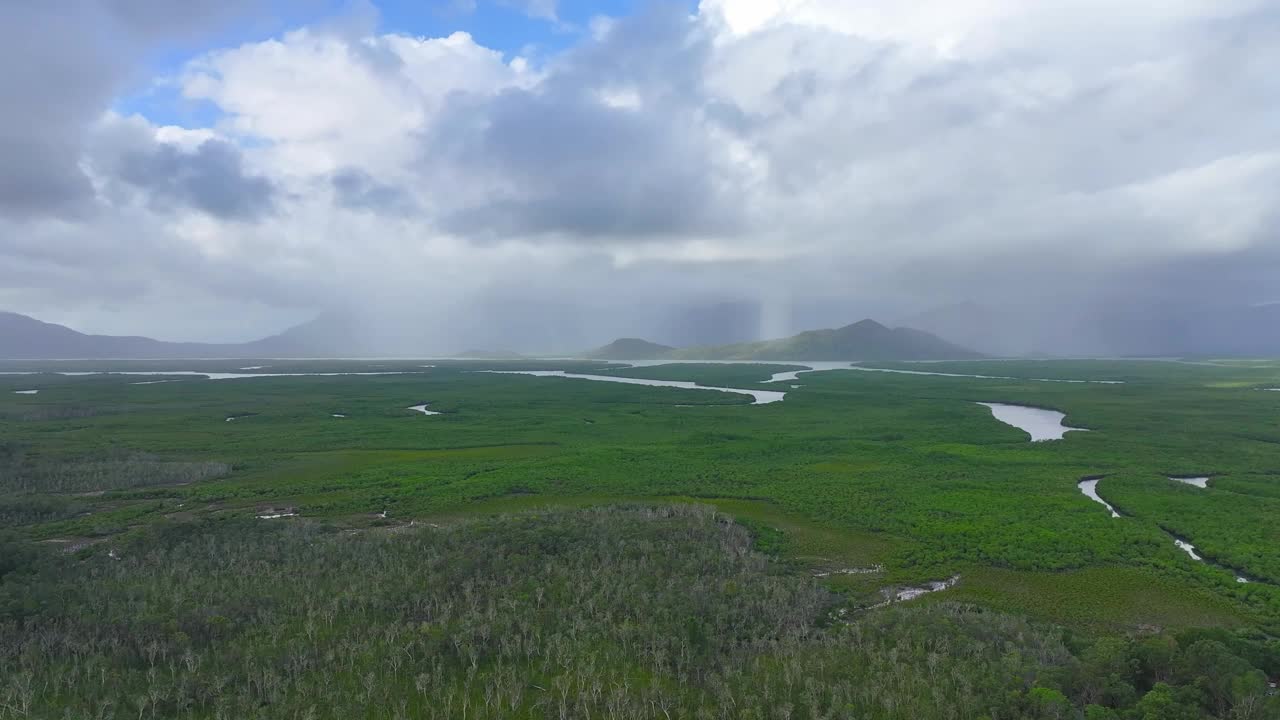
0, 0, 263, 219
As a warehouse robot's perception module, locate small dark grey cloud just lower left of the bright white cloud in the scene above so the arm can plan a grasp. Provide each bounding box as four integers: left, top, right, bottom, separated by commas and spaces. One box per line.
115, 140, 276, 220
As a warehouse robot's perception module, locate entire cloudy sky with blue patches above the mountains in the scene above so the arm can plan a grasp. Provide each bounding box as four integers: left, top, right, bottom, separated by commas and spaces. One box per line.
0, 0, 1280, 351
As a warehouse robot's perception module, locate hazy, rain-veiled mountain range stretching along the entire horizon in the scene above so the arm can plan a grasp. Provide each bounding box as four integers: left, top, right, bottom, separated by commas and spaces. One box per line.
12, 301, 1280, 360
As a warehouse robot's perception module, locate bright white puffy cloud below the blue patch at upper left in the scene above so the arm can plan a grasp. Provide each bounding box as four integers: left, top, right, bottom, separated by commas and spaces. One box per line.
183, 29, 525, 174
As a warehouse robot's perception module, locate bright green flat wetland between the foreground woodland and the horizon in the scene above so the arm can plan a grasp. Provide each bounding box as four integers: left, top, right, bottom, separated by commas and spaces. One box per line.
0, 360, 1280, 717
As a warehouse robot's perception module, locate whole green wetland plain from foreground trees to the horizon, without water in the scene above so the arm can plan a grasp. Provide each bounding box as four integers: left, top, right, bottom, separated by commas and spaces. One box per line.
0, 360, 1280, 719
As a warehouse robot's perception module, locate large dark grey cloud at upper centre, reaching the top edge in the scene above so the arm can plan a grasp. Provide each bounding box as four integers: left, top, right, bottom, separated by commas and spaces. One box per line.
426, 5, 737, 242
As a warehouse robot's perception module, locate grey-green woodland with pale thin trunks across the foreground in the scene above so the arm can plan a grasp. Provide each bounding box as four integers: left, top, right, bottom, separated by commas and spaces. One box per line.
0, 506, 1280, 719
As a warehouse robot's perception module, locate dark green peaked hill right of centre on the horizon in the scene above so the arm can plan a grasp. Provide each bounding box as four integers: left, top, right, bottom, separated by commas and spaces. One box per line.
669, 320, 982, 360
